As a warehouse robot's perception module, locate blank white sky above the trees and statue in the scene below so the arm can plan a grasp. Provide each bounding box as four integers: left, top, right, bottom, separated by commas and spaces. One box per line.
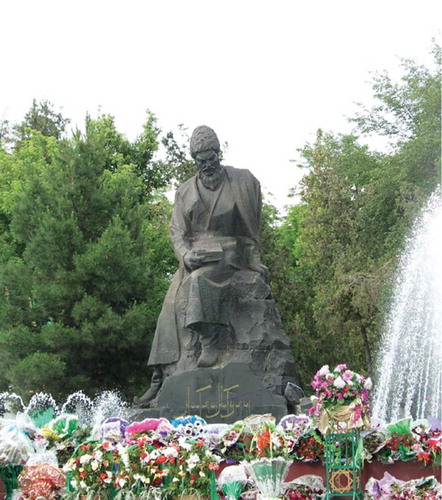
0, 0, 442, 209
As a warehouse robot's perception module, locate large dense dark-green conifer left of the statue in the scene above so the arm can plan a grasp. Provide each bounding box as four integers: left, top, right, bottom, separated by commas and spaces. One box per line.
0, 117, 175, 397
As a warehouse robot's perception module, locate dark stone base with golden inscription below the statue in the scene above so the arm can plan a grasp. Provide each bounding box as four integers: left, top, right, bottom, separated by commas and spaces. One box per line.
132, 363, 287, 423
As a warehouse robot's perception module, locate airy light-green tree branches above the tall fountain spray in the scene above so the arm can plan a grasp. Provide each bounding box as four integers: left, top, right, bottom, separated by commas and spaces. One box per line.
352, 42, 442, 198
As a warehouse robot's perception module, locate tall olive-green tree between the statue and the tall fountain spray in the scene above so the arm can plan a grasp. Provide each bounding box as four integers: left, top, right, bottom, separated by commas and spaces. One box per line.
300, 131, 386, 372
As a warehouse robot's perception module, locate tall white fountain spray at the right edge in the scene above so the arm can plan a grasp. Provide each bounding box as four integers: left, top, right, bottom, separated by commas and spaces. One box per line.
373, 186, 442, 422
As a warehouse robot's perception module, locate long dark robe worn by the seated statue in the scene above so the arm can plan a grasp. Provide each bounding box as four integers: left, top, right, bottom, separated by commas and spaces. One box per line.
148, 167, 262, 365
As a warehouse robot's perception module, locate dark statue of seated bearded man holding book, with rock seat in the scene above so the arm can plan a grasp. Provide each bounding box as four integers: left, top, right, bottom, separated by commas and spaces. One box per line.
135, 126, 296, 416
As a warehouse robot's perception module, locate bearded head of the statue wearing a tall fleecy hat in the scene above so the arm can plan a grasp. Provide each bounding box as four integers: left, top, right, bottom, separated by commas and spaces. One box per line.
190, 125, 220, 177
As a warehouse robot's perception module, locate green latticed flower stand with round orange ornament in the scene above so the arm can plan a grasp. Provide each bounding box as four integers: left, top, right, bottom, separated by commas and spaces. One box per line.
325, 432, 364, 500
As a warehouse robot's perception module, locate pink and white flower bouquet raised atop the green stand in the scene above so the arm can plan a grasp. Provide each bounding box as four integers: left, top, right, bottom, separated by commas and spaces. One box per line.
310, 364, 372, 434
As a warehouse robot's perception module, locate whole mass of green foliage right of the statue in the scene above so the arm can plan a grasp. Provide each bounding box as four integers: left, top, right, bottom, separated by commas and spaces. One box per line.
274, 47, 441, 380
